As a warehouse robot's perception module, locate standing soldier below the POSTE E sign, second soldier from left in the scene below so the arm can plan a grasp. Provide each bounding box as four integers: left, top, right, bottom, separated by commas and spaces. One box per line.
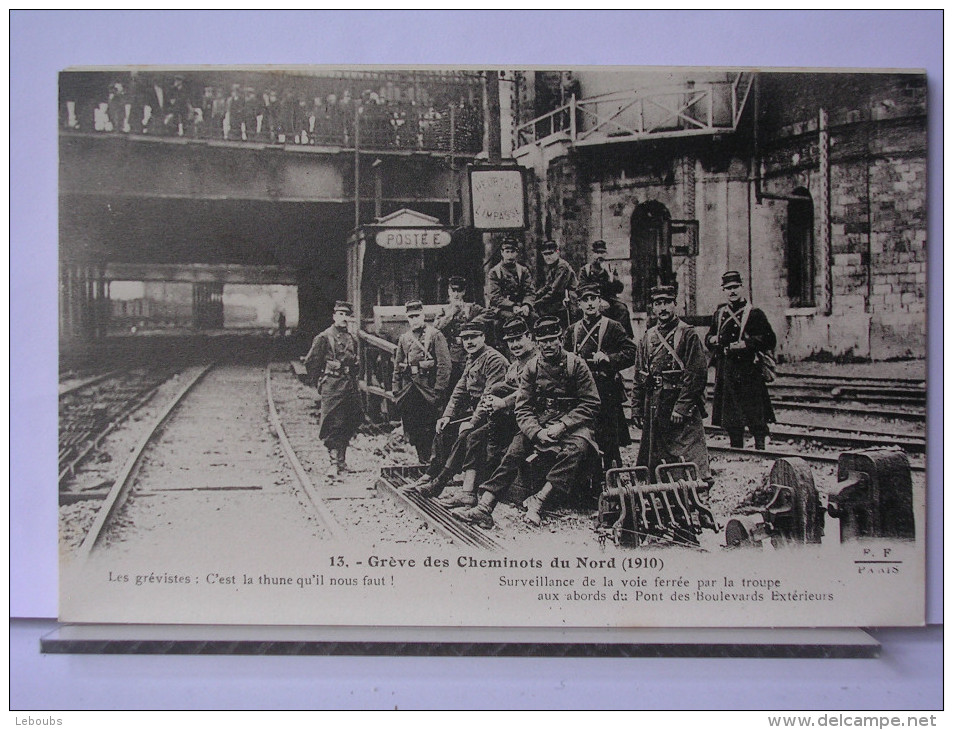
391, 301, 450, 464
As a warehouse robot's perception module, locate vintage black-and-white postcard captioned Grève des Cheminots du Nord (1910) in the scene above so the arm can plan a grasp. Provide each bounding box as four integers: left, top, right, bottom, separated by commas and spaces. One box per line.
58, 67, 933, 628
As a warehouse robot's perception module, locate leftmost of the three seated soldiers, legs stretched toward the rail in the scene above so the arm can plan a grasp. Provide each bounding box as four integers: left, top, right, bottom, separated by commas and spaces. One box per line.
412, 321, 507, 506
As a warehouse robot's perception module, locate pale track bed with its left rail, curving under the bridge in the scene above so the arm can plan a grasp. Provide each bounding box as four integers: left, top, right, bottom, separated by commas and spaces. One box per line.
77, 364, 344, 558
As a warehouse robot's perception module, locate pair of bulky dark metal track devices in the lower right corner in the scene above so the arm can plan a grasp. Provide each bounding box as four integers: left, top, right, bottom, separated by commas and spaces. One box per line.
725, 448, 915, 547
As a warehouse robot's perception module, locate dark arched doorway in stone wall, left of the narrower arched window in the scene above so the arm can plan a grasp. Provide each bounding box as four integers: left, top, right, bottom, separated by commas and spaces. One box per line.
629, 200, 675, 312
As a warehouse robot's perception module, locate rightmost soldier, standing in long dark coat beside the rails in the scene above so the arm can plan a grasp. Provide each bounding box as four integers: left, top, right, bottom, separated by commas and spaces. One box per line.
706, 271, 777, 450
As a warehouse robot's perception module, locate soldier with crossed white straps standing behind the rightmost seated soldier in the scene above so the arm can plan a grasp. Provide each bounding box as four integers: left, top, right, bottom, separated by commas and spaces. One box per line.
565, 283, 635, 470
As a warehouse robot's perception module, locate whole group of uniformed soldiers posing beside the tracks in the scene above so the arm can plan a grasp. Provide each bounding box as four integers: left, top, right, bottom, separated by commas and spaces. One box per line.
305, 241, 776, 528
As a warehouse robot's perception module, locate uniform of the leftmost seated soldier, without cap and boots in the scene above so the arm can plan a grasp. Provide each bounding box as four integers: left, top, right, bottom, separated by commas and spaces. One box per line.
427, 347, 508, 481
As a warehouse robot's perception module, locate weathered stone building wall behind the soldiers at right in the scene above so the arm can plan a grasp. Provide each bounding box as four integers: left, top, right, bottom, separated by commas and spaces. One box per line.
524, 75, 927, 360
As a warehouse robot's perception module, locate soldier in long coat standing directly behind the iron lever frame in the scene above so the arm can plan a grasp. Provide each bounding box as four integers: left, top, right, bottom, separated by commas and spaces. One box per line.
632, 286, 711, 481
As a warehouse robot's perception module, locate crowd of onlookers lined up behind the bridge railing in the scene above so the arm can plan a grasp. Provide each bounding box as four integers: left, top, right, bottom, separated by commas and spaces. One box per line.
60, 72, 483, 153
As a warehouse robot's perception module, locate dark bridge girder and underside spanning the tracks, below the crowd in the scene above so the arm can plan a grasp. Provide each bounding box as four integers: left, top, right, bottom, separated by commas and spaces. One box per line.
59, 123, 472, 348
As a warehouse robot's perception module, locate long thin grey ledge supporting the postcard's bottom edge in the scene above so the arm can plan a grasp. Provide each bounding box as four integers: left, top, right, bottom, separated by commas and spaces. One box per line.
40, 624, 880, 659
